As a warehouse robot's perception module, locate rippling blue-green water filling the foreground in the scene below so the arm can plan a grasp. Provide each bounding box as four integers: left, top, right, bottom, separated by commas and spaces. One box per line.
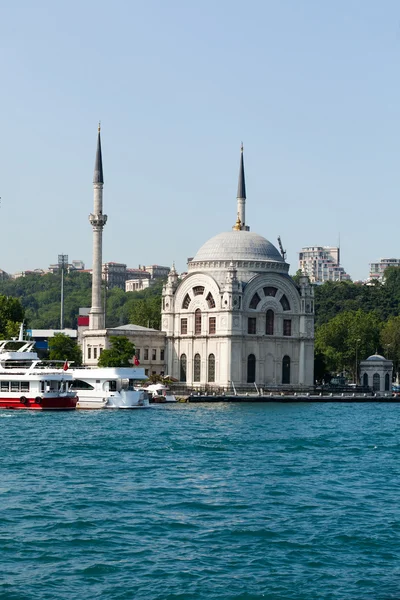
0, 404, 400, 600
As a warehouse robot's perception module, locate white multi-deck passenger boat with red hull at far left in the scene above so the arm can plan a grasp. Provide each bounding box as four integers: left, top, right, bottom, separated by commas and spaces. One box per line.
0, 328, 78, 410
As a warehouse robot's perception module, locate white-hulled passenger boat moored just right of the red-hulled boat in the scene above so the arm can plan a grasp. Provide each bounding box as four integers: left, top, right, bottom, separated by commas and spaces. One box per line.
68, 367, 149, 409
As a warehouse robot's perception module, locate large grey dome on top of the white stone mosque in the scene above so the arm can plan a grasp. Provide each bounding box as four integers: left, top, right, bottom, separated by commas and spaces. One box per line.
192, 230, 285, 263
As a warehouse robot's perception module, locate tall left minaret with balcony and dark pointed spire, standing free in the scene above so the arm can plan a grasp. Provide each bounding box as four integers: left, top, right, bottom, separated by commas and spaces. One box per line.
89, 123, 107, 329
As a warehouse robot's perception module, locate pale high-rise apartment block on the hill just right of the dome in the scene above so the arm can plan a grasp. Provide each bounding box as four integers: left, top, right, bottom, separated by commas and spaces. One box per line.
299, 246, 351, 283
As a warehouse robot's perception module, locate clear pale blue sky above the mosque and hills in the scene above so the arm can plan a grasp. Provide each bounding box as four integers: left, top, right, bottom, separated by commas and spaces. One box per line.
0, 0, 400, 280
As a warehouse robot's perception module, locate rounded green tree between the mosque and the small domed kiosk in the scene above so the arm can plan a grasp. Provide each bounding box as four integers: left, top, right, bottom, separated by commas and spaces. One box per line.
315, 309, 381, 378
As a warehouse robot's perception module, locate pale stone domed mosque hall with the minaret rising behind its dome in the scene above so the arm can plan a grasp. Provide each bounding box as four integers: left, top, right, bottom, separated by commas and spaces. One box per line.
161, 146, 314, 389
